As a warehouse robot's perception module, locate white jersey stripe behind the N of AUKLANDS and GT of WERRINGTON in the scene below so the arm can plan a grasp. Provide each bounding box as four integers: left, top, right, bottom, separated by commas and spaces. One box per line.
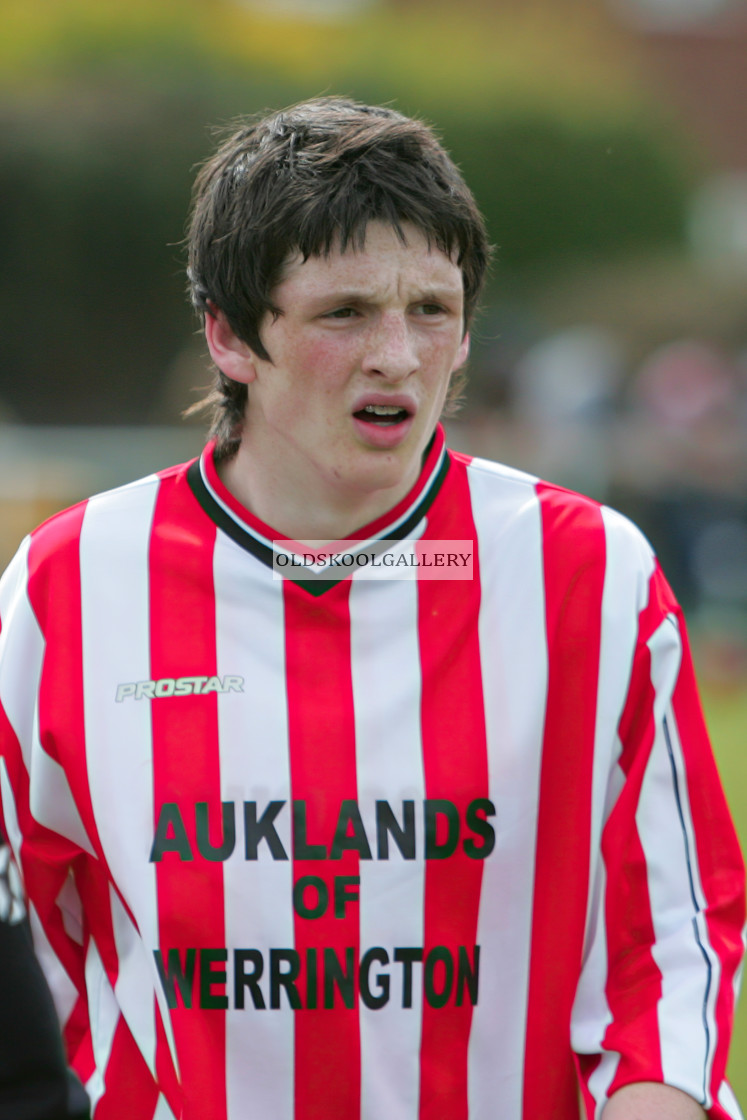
349, 580, 424, 1120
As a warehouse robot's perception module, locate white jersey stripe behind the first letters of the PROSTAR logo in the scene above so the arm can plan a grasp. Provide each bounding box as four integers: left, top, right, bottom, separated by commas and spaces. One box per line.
81, 478, 176, 1065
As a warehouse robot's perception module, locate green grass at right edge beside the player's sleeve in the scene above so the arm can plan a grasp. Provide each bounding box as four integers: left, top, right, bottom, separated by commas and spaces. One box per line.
702, 689, 747, 1110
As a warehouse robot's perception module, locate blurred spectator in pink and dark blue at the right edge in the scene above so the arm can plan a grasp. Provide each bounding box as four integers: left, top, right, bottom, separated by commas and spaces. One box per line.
614, 338, 747, 647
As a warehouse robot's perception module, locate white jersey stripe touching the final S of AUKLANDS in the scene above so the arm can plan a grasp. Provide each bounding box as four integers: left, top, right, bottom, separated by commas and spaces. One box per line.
468, 460, 548, 1120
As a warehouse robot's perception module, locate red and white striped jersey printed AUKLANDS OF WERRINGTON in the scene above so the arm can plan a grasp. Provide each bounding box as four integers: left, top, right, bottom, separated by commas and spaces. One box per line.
0, 430, 745, 1120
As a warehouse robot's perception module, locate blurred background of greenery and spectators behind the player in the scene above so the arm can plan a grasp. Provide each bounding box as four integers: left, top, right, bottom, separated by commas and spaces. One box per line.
0, 0, 747, 1101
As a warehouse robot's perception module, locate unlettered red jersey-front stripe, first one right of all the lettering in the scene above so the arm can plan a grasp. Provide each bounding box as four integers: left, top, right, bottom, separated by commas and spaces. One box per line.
523, 485, 605, 1120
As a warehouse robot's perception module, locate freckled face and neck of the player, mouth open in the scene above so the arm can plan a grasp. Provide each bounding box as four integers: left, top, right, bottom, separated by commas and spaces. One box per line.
225, 222, 468, 528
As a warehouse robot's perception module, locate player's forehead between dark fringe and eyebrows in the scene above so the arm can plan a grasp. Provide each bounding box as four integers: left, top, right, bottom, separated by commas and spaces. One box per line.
276, 222, 463, 295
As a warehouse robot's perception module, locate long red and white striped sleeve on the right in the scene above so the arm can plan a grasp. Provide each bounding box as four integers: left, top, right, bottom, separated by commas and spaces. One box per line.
572, 567, 745, 1120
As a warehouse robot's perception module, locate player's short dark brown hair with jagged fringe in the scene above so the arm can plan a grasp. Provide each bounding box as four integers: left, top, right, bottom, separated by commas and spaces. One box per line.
187, 97, 489, 458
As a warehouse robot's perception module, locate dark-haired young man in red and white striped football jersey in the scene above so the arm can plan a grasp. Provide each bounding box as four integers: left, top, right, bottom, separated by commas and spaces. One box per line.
0, 99, 745, 1120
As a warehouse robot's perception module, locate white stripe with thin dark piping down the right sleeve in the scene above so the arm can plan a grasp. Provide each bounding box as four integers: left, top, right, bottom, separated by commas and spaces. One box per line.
636, 619, 720, 1107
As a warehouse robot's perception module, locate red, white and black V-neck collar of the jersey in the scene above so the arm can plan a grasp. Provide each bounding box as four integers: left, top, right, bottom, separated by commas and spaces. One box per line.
187, 424, 449, 595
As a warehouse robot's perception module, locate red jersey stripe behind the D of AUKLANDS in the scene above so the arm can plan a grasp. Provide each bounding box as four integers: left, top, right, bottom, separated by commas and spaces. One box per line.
418, 459, 488, 1120
